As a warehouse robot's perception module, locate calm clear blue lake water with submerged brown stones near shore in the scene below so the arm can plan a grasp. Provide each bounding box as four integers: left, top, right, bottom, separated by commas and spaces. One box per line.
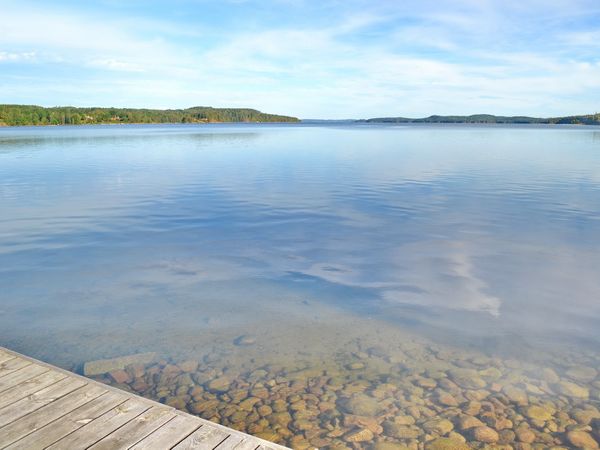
0, 124, 600, 450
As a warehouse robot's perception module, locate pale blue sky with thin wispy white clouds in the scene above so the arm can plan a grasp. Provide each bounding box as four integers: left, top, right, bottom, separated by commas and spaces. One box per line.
0, 0, 600, 119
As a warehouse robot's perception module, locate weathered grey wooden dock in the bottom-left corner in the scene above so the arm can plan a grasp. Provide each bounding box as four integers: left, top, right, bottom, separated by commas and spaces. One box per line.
0, 347, 287, 450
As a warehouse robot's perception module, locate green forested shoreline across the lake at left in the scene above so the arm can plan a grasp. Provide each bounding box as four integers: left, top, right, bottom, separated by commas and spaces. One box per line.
0, 105, 300, 126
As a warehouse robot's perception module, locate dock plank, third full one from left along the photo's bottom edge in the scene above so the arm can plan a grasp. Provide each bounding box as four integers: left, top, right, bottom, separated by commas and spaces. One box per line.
89, 406, 175, 450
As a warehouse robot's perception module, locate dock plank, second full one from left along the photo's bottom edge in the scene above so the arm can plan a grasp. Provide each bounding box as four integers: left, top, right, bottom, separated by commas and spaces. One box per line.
47, 398, 150, 450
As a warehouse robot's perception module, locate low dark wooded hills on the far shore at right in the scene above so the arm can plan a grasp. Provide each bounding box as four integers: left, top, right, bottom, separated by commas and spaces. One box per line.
358, 114, 600, 125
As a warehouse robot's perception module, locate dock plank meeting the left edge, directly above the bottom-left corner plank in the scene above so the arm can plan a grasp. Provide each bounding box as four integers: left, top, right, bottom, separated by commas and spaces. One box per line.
0, 378, 87, 427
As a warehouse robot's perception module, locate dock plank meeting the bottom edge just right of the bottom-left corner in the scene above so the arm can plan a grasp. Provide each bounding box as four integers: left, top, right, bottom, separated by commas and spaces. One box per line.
6, 392, 127, 450
